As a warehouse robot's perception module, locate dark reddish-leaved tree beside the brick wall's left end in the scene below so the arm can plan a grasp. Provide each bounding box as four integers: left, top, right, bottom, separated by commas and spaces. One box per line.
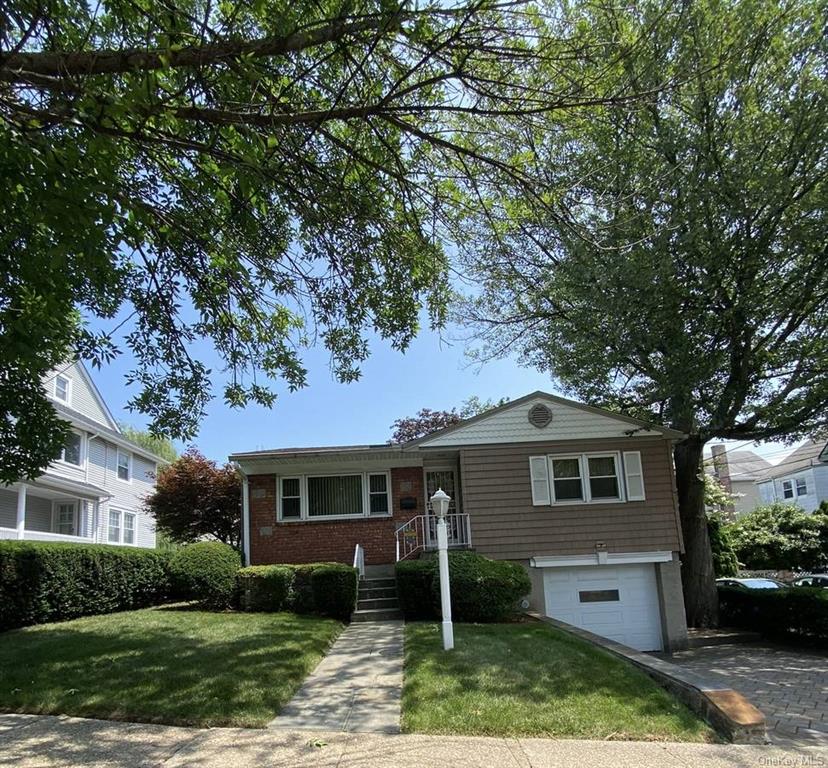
144, 447, 241, 548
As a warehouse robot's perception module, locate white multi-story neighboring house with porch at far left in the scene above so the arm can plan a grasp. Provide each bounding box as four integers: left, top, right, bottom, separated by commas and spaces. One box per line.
0, 362, 164, 547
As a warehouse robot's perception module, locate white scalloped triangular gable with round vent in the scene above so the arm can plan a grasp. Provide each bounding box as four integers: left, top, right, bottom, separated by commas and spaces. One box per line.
406, 392, 683, 448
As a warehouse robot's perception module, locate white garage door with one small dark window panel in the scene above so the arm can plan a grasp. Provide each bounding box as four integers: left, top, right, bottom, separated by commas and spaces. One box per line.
544, 563, 662, 651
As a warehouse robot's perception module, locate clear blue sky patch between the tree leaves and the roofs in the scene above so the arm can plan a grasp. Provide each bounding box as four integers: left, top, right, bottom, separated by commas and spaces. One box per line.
95, 320, 557, 460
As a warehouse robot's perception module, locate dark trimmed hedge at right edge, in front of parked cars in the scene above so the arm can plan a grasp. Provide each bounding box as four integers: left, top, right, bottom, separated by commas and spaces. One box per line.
719, 587, 828, 644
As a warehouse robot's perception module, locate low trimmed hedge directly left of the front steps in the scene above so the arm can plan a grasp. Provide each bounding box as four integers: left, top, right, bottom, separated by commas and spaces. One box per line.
236, 563, 358, 621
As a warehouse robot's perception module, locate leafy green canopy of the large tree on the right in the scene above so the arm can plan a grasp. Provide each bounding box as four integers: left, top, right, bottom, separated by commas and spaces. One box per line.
459, 0, 828, 441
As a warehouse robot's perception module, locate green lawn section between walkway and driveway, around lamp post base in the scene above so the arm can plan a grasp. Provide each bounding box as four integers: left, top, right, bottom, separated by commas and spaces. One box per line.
403, 623, 716, 741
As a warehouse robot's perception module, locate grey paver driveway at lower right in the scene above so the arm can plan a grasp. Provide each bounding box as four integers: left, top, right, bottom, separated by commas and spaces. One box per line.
665, 643, 828, 747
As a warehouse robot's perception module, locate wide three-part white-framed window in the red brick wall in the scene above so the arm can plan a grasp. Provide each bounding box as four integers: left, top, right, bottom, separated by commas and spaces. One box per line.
278, 472, 391, 521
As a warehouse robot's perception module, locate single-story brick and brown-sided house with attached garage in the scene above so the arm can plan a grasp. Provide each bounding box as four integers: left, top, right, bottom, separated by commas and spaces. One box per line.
230, 392, 687, 650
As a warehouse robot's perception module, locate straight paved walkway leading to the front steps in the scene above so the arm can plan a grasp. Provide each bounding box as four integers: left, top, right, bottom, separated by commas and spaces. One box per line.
268, 621, 403, 733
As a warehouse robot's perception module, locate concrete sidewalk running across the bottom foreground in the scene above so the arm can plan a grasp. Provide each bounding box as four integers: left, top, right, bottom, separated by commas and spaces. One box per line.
0, 715, 828, 768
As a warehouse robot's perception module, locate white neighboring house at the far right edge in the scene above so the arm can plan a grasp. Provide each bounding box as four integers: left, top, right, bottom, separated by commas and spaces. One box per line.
756, 440, 828, 512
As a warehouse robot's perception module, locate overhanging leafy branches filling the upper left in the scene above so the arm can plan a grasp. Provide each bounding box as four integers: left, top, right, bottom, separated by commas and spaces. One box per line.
0, 0, 636, 480
